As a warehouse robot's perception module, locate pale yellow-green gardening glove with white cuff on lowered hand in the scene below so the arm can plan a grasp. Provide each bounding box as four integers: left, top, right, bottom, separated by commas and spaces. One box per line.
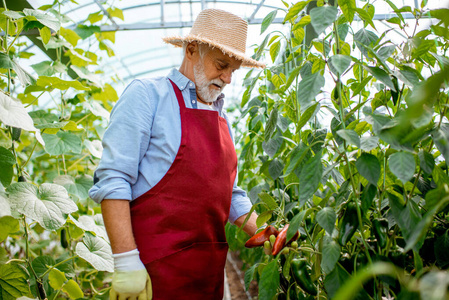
109, 249, 153, 300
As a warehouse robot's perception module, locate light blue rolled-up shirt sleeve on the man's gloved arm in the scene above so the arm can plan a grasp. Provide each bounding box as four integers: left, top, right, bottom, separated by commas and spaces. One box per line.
89, 80, 154, 203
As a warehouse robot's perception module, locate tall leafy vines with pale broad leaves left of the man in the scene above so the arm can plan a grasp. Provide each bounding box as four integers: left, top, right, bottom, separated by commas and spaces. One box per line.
0, 0, 123, 300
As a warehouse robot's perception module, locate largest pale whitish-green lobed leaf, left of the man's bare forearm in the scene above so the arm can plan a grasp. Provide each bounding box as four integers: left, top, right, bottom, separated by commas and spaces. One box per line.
7, 182, 78, 230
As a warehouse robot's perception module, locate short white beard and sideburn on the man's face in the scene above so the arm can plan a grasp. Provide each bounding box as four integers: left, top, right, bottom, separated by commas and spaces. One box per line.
193, 61, 226, 103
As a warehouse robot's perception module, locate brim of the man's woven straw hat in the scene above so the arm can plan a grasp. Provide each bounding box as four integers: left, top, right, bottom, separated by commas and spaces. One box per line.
162, 35, 265, 68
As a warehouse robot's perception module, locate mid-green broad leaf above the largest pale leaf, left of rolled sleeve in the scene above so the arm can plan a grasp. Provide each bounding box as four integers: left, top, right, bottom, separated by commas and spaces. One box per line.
42, 131, 82, 155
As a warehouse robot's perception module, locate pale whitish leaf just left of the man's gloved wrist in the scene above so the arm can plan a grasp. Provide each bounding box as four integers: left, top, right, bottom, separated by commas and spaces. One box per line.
76, 233, 114, 272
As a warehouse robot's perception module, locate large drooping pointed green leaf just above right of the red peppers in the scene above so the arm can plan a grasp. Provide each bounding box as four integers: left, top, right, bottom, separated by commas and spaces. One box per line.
298, 152, 323, 207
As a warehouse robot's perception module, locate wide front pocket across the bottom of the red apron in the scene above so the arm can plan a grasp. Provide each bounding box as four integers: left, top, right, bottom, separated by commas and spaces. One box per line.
145, 242, 228, 300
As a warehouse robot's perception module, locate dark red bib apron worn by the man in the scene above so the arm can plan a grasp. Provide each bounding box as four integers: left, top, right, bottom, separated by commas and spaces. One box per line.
131, 78, 237, 300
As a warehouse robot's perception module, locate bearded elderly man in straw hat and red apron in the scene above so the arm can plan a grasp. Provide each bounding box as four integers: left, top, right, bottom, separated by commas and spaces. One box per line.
90, 9, 263, 300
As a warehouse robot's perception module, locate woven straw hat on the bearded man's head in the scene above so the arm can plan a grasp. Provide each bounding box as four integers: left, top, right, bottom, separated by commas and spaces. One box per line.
163, 8, 265, 68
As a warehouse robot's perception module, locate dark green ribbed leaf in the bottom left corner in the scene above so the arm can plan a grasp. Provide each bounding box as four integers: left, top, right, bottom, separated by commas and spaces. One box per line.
0, 264, 31, 300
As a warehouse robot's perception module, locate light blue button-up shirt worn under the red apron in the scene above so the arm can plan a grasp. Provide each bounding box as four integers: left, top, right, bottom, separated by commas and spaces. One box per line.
89, 69, 251, 223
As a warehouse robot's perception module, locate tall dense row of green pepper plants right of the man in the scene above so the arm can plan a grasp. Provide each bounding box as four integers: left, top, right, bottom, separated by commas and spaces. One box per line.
227, 0, 449, 300
